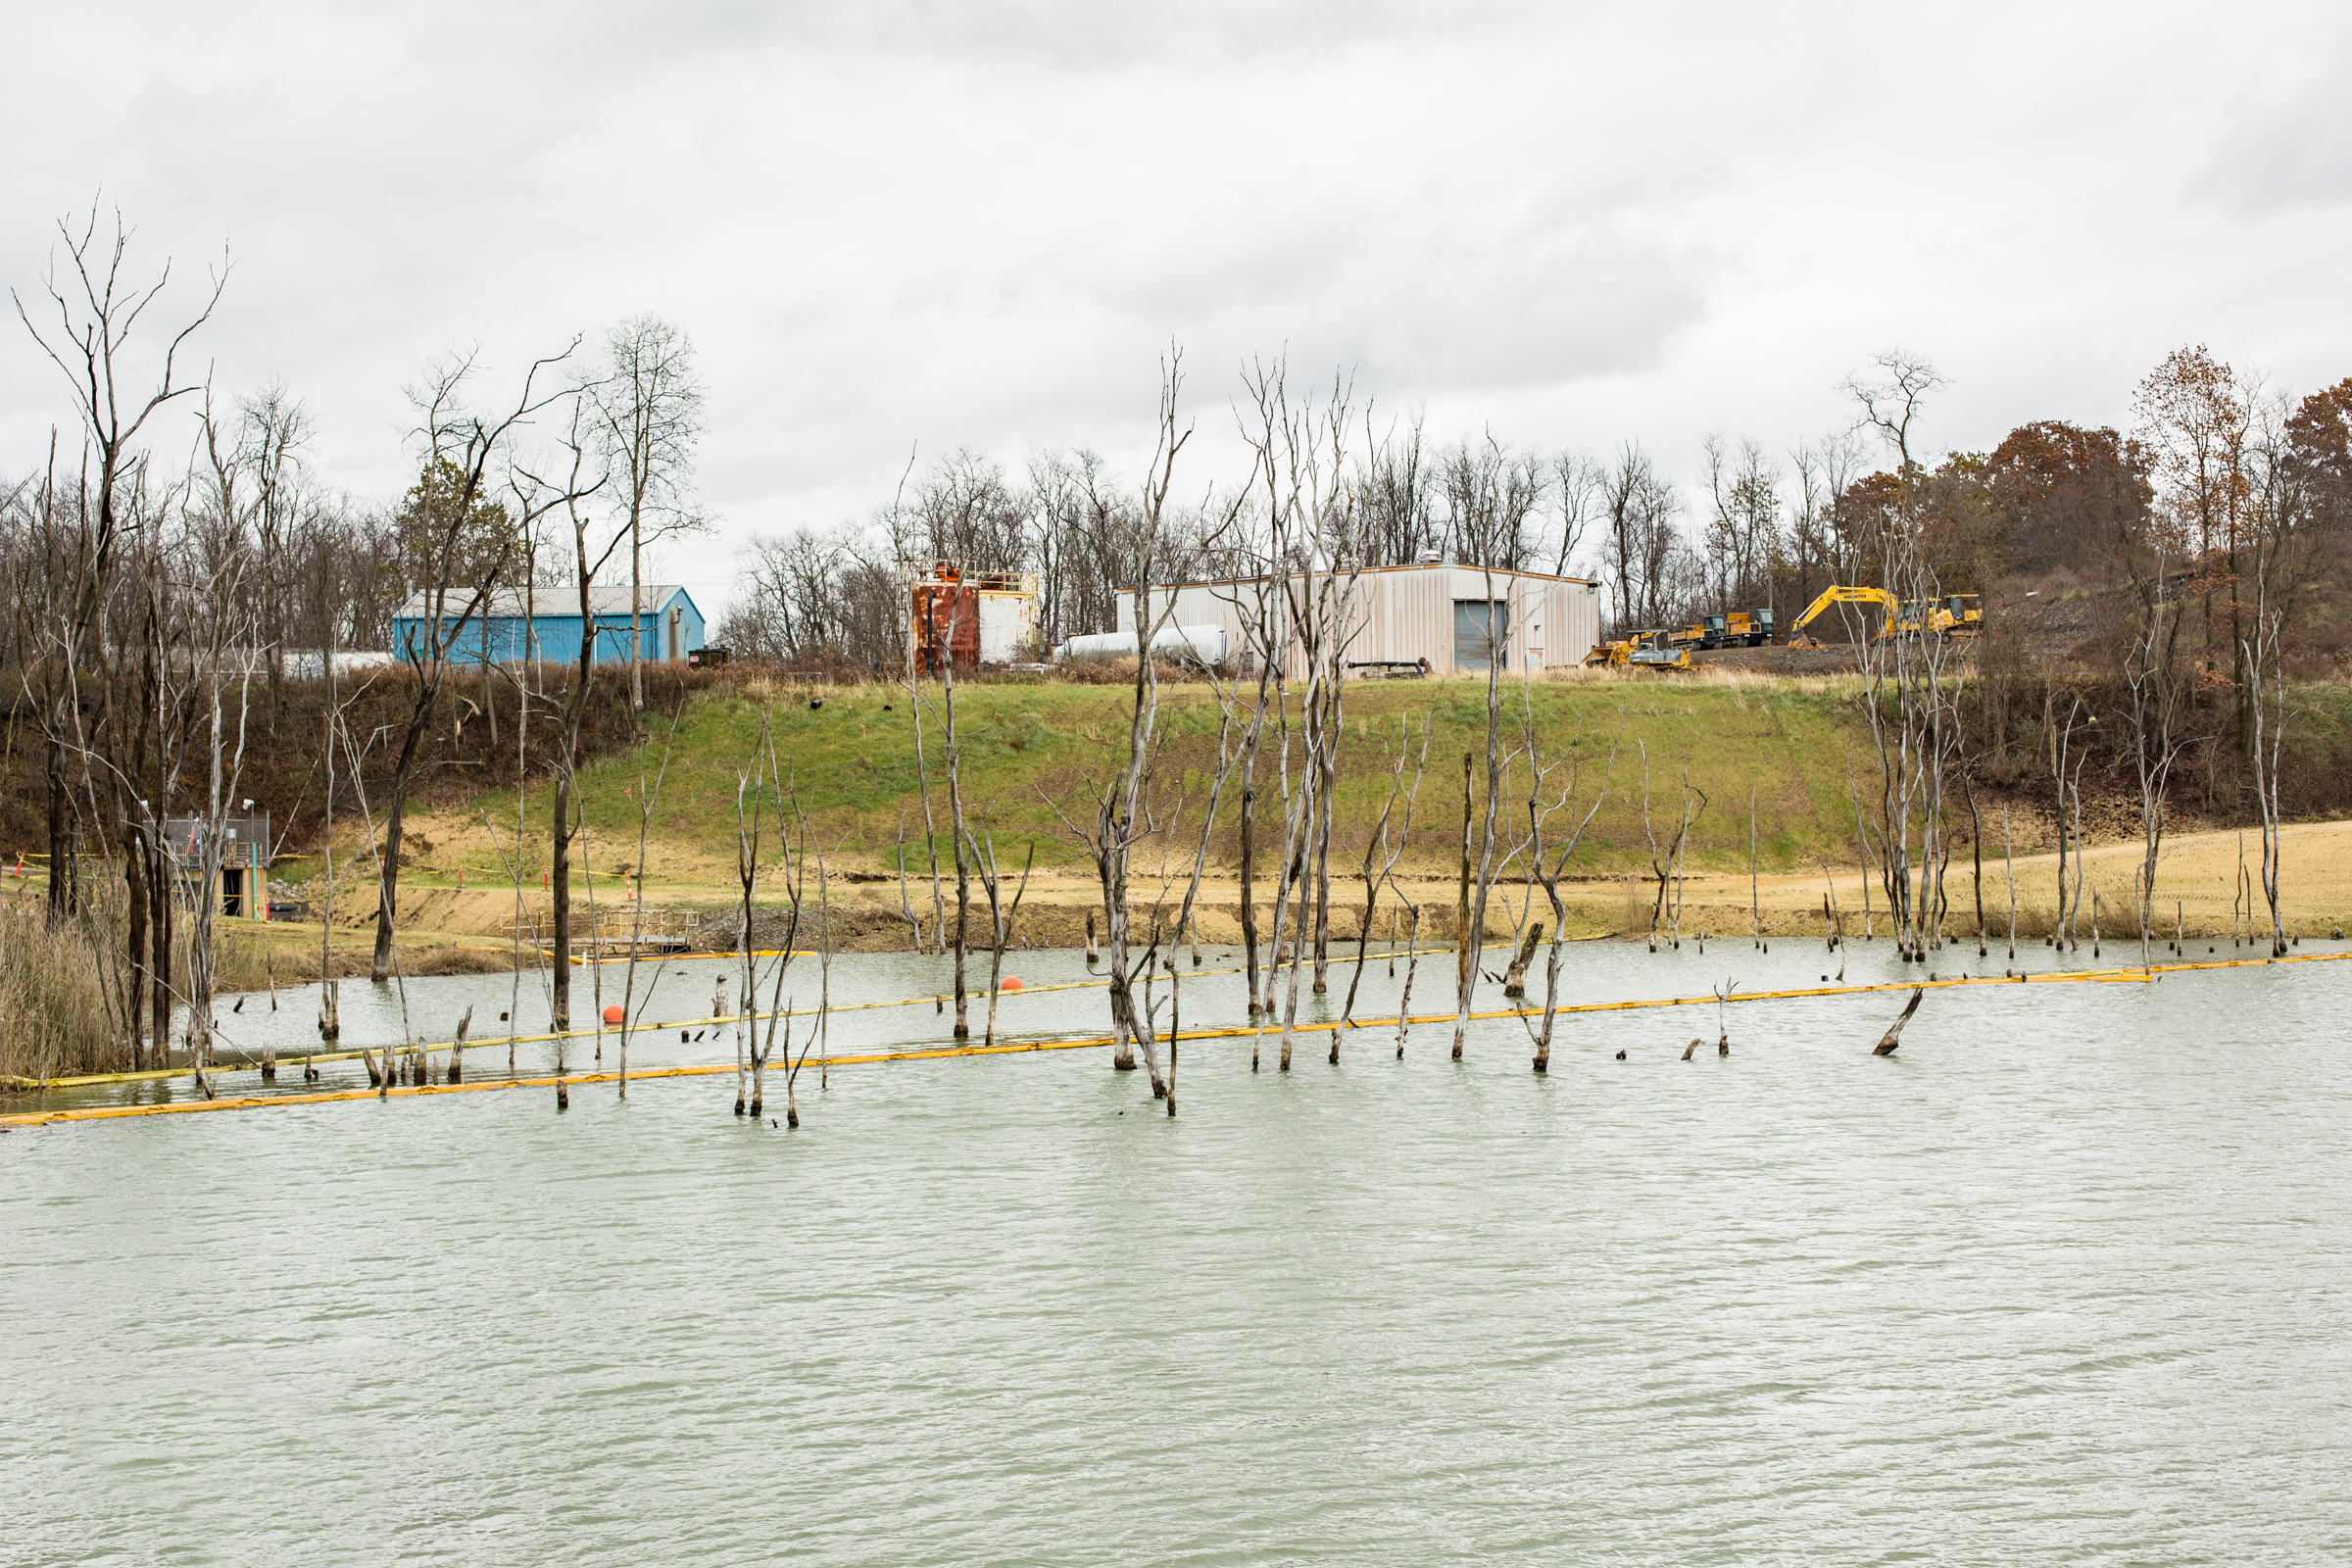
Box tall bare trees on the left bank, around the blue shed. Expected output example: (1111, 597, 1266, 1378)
(0, 212, 706, 1093)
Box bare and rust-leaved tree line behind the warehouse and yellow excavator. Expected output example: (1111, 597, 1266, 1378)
(717, 348, 2352, 672)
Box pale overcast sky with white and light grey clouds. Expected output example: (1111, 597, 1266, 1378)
(0, 0, 2352, 609)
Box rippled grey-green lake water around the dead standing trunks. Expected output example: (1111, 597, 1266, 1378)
(0, 941, 2352, 1563)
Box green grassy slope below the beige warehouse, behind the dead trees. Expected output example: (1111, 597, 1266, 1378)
(444, 677, 1875, 882)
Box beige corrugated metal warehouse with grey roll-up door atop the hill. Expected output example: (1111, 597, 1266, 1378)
(1117, 566, 1601, 679)
